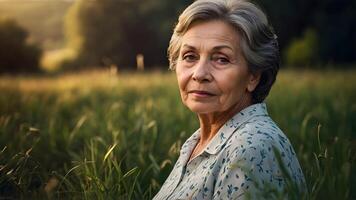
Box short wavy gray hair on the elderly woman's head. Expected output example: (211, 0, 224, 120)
(168, 0, 280, 103)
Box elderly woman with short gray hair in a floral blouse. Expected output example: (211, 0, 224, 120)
(154, 0, 305, 199)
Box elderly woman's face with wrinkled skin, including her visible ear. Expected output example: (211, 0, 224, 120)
(176, 20, 258, 114)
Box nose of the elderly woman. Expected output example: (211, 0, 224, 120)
(192, 59, 213, 82)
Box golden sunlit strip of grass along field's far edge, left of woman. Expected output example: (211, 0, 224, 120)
(0, 70, 176, 93)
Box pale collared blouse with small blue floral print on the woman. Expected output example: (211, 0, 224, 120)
(153, 103, 305, 200)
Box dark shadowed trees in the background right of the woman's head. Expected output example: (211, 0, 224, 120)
(256, 0, 356, 64)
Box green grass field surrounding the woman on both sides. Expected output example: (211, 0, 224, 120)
(0, 70, 356, 199)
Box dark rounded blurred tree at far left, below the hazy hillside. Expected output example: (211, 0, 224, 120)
(0, 19, 42, 73)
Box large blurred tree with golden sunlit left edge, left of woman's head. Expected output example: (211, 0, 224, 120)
(66, 0, 191, 68)
